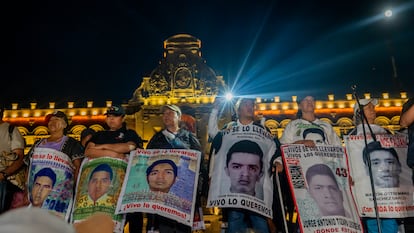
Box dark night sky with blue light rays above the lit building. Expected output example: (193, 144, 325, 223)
(6, 0, 414, 107)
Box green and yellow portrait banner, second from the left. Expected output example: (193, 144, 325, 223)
(72, 157, 128, 232)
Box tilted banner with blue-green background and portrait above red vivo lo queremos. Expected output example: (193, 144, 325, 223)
(116, 149, 200, 226)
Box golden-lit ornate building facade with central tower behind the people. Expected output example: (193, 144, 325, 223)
(4, 34, 407, 157)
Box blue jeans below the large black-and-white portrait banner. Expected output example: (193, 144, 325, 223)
(227, 209, 269, 233)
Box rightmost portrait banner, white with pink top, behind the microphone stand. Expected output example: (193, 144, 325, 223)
(344, 135, 414, 218)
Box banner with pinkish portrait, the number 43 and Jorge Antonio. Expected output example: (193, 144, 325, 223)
(282, 144, 362, 233)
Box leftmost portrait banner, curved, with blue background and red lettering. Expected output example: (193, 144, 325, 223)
(28, 148, 74, 221)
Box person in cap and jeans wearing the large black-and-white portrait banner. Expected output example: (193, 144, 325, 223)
(209, 98, 278, 233)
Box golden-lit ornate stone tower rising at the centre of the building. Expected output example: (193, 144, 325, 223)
(126, 34, 225, 155)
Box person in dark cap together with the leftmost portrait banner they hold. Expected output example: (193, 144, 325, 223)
(25, 111, 84, 219)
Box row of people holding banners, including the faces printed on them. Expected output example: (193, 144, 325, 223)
(0, 95, 414, 233)
